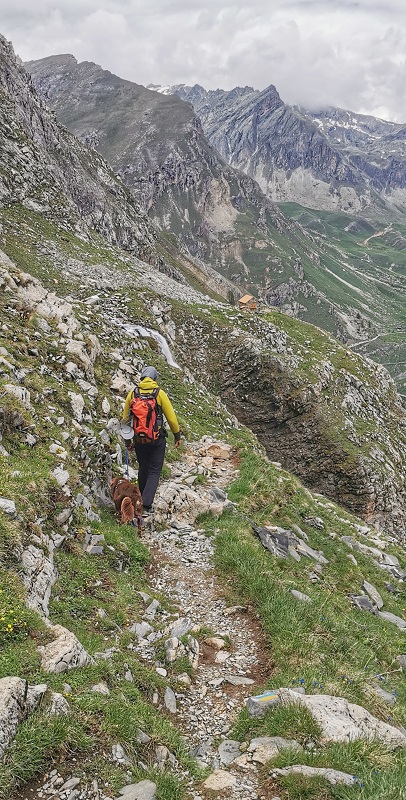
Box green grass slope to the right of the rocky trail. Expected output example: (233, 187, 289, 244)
(206, 442, 406, 800)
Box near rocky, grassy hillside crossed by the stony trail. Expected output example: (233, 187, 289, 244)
(0, 230, 406, 800)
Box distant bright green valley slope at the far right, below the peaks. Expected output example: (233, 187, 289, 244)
(281, 203, 406, 391)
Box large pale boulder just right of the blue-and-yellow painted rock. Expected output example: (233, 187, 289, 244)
(278, 689, 406, 749)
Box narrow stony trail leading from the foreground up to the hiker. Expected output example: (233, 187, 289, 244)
(16, 437, 266, 800)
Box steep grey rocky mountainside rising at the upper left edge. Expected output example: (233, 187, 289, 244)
(0, 36, 156, 258)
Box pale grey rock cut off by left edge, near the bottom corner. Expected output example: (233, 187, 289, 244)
(0, 677, 47, 758)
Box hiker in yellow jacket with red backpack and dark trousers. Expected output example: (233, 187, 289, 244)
(122, 367, 181, 515)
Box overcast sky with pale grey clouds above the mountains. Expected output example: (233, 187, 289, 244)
(0, 0, 406, 123)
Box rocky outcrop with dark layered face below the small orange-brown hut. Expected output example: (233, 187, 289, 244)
(173, 306, 406, 539)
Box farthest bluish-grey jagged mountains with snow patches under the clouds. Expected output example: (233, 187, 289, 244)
(150, 84, 406, 216)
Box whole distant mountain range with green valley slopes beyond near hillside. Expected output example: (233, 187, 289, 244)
(25, 55, 406, 387)
